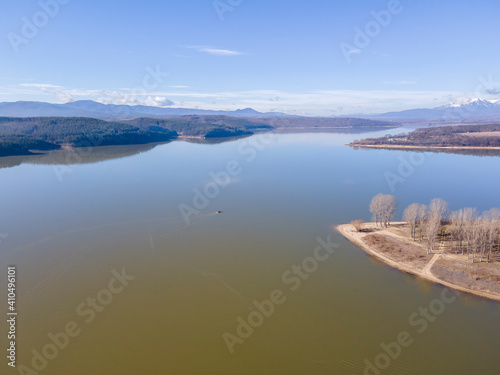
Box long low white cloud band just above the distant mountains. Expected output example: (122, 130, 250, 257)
(8, 83, 468, 116)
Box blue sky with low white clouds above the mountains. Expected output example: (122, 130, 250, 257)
(0, 0, 500, 116)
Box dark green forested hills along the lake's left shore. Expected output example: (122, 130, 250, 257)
(0, 116, 273, 156)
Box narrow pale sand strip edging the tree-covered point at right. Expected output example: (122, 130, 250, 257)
(335, 222, 500, 302)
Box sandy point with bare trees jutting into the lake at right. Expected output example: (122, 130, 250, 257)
(336, 194, 500, 301)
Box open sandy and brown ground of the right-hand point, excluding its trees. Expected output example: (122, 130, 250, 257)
(336, 222, 500, 301)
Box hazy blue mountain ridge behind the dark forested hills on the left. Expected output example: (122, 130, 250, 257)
(0, 100, 288, 120)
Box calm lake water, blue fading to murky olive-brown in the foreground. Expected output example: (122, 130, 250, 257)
(0, 131, 500, 375)
